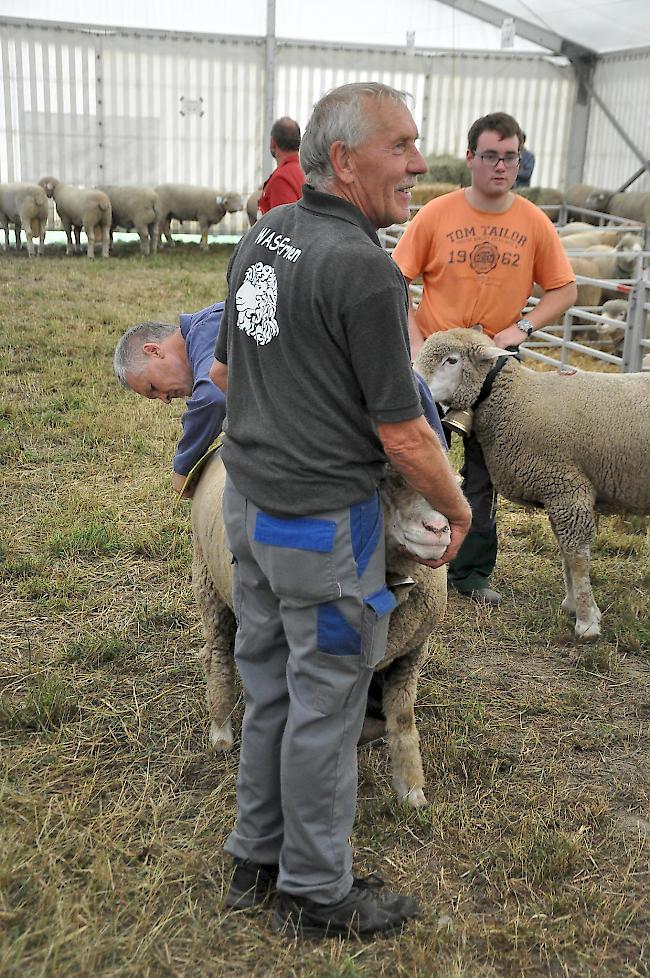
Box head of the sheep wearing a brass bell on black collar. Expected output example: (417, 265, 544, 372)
(414, 329, 512, 409)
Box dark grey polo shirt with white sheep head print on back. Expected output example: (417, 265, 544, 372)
(215, 186, 422, 516)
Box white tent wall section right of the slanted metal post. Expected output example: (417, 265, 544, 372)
(584, 48, 650, 191)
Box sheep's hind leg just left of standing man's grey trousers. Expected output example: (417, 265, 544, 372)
(192, 535, 237, 751)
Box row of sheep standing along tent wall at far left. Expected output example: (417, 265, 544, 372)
(0, 177, 244, 258)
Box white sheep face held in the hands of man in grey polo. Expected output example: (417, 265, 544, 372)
(381, 470, 451, 560)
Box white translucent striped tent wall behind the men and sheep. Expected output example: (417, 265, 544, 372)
(0, 18, 650, 233)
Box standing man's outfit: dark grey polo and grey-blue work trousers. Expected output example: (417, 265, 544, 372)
(216, 187, 422, 903)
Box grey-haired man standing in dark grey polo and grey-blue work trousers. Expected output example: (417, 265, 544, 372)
(210, 82, 471, 937)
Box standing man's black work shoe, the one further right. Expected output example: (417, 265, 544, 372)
(271, 876, 420, 938)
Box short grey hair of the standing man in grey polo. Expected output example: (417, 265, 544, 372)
(300, 82, 410, 190)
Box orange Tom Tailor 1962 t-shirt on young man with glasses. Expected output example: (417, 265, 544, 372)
(393, 189, 575, 336)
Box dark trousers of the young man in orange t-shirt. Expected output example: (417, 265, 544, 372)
(448, 434, 497, 594)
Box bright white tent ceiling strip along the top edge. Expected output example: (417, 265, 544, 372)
(0, 0, 650, 53)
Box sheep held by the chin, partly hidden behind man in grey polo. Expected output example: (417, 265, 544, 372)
(192, 455, 450, 808)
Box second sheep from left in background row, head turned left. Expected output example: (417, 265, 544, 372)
(38, 177, 112, 258)
